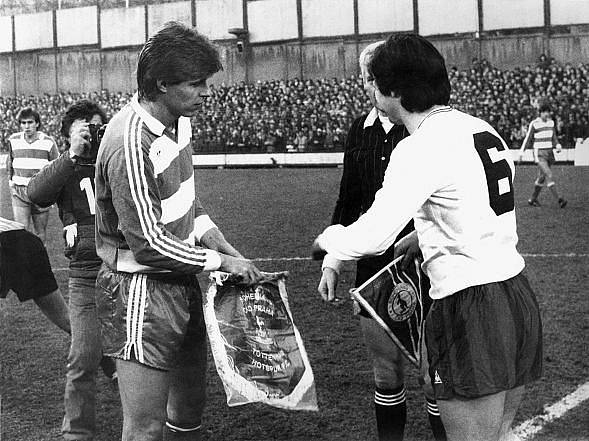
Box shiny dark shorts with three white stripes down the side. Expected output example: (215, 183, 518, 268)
(96, 265, 206, 370)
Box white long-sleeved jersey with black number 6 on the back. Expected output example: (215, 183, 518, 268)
(318, 107, 524, 299)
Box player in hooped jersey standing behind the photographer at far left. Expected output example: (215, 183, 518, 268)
(6, 107, 58, 243)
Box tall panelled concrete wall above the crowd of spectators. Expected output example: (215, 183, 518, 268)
(0, 0, 589, 94)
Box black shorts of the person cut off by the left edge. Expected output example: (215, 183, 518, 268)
(0, 230, 58, 302)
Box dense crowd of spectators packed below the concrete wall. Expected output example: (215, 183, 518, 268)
(0, 56, 589, 153)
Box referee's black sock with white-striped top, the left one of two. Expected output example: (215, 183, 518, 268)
(374, 386, 407, 441)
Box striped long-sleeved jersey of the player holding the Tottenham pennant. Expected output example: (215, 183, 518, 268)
(96, 95, 220, 274)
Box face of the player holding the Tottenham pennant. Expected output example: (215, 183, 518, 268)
(163, 79, 210, 118)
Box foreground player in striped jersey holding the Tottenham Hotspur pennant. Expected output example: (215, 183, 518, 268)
(96, 22, 262, 441)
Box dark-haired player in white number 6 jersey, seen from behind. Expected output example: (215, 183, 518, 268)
(313, 34, 542, 441)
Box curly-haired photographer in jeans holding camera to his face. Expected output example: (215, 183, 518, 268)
(28, 100, 116, 440)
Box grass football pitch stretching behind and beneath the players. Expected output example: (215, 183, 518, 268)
(0, 166, 589, 441)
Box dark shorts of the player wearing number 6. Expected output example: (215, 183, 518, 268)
(426, 274, 542, 400)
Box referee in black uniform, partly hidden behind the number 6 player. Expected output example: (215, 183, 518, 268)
(318, 41, 446, 441)
